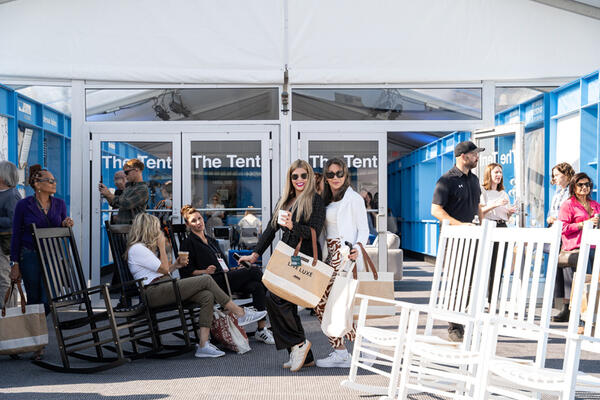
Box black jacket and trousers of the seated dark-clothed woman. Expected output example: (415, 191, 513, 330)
(179, 233, 267, 311)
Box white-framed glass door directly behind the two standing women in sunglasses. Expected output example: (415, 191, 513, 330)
(297, 130, 387, 271)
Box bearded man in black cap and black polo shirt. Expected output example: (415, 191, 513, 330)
(431, 141, 485, 342)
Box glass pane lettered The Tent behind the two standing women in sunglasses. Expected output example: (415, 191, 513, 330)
(308, 140, 379, 241)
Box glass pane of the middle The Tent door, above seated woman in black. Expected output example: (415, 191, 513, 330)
(184, 140, 263, 258)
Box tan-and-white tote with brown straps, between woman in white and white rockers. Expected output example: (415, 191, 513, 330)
(354, 243, 396, 320)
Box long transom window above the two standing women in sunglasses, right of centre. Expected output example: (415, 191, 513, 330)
(292, 88, 481, 121)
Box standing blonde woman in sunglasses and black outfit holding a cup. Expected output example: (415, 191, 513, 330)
(239, 160, 325, 372)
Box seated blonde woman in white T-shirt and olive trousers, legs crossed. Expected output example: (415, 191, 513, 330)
(127, 213, 267, 358)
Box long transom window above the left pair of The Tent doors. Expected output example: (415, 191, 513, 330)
(85, 88, 279, 121)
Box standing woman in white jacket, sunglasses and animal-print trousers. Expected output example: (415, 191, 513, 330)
(315, 158, 369, 368)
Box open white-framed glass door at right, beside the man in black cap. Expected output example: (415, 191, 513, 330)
(473, 123, 524, 227)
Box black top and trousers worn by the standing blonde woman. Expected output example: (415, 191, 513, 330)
(254, 194, 325, 352)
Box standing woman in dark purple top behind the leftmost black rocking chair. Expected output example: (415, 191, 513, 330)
(10, 164, 73, 359)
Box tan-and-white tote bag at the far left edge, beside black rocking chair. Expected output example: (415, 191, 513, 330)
(0, 281, 48, 354)
